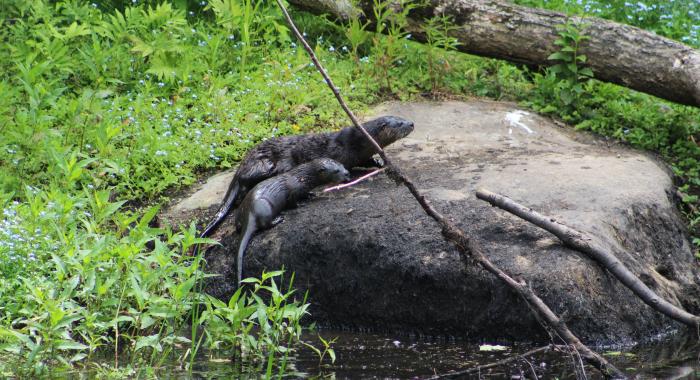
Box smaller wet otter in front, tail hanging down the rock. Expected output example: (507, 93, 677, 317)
(235, 158, 350, 287)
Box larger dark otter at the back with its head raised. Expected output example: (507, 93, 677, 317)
(195, 116, 413, 243)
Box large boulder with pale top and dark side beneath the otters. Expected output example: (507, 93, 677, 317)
(165, 101, 699, 343)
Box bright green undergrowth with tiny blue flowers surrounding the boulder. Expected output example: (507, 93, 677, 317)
(0, 0, 700, 376)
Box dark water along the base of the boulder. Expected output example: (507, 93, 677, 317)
(183, 330, 700, 379)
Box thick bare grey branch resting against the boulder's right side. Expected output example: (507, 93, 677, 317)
(476, 189, 700, 329)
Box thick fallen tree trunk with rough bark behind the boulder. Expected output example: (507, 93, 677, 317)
(289, 0, 700, 107)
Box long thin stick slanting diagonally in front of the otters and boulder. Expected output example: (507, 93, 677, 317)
(277, 0, 625, 378)
